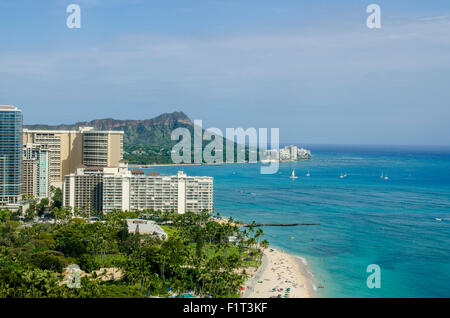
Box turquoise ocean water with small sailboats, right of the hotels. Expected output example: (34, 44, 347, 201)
(143, 146, 450, 297)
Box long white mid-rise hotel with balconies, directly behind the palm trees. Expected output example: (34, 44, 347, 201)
(63, 162, 213, 214)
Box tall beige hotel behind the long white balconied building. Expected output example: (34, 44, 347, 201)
(23, 127, 124, 187)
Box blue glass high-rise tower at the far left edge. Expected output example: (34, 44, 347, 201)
(0, 105, 22, 206)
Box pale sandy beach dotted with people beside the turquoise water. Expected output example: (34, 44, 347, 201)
(242, 247, 313, 298)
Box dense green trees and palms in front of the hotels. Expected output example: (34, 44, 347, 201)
(0, 188, 268, 298)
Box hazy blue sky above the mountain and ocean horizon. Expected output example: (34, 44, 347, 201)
(0, 0, 450, 145)
